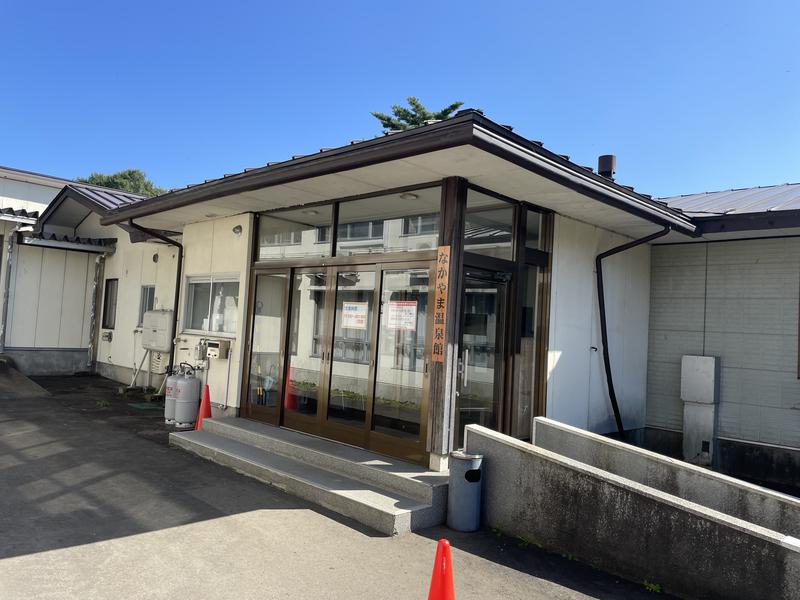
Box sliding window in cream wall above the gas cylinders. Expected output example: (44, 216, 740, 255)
(184, 277, 239, 334)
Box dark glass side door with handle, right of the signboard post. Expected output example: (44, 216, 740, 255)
(455, 269, 508, 447)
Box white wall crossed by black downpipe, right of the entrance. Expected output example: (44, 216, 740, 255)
(547, 215, 650, 433)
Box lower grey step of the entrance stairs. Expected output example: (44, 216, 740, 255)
(170, 428, 442, 535)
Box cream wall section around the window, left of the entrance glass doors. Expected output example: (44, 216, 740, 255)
(175, 214, 253, 407)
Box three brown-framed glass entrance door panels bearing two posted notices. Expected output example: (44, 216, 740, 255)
(274, 262, 433, 462)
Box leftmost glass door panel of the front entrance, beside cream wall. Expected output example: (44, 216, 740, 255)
(243, 272, 289, 425)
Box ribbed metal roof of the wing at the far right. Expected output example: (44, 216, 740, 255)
(659, 183, 800, 217)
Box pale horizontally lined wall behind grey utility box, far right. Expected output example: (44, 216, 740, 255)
(647, 238, 800, 448)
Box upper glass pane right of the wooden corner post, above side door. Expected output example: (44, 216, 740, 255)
(464, 190, 514, 260)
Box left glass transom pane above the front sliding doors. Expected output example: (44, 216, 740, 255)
(256, 205, 332, 260)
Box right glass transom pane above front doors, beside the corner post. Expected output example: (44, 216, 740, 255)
(336, 187, 442, 256)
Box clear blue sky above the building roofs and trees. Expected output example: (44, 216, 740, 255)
(0, 0, 800, 196)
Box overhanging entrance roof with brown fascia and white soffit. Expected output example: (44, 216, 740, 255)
(101, 110, 695, 235)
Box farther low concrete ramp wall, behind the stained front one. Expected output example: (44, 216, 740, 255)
(532, 417, 800, 538)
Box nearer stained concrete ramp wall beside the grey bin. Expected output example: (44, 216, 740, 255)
(465, 425, 800, 600)
